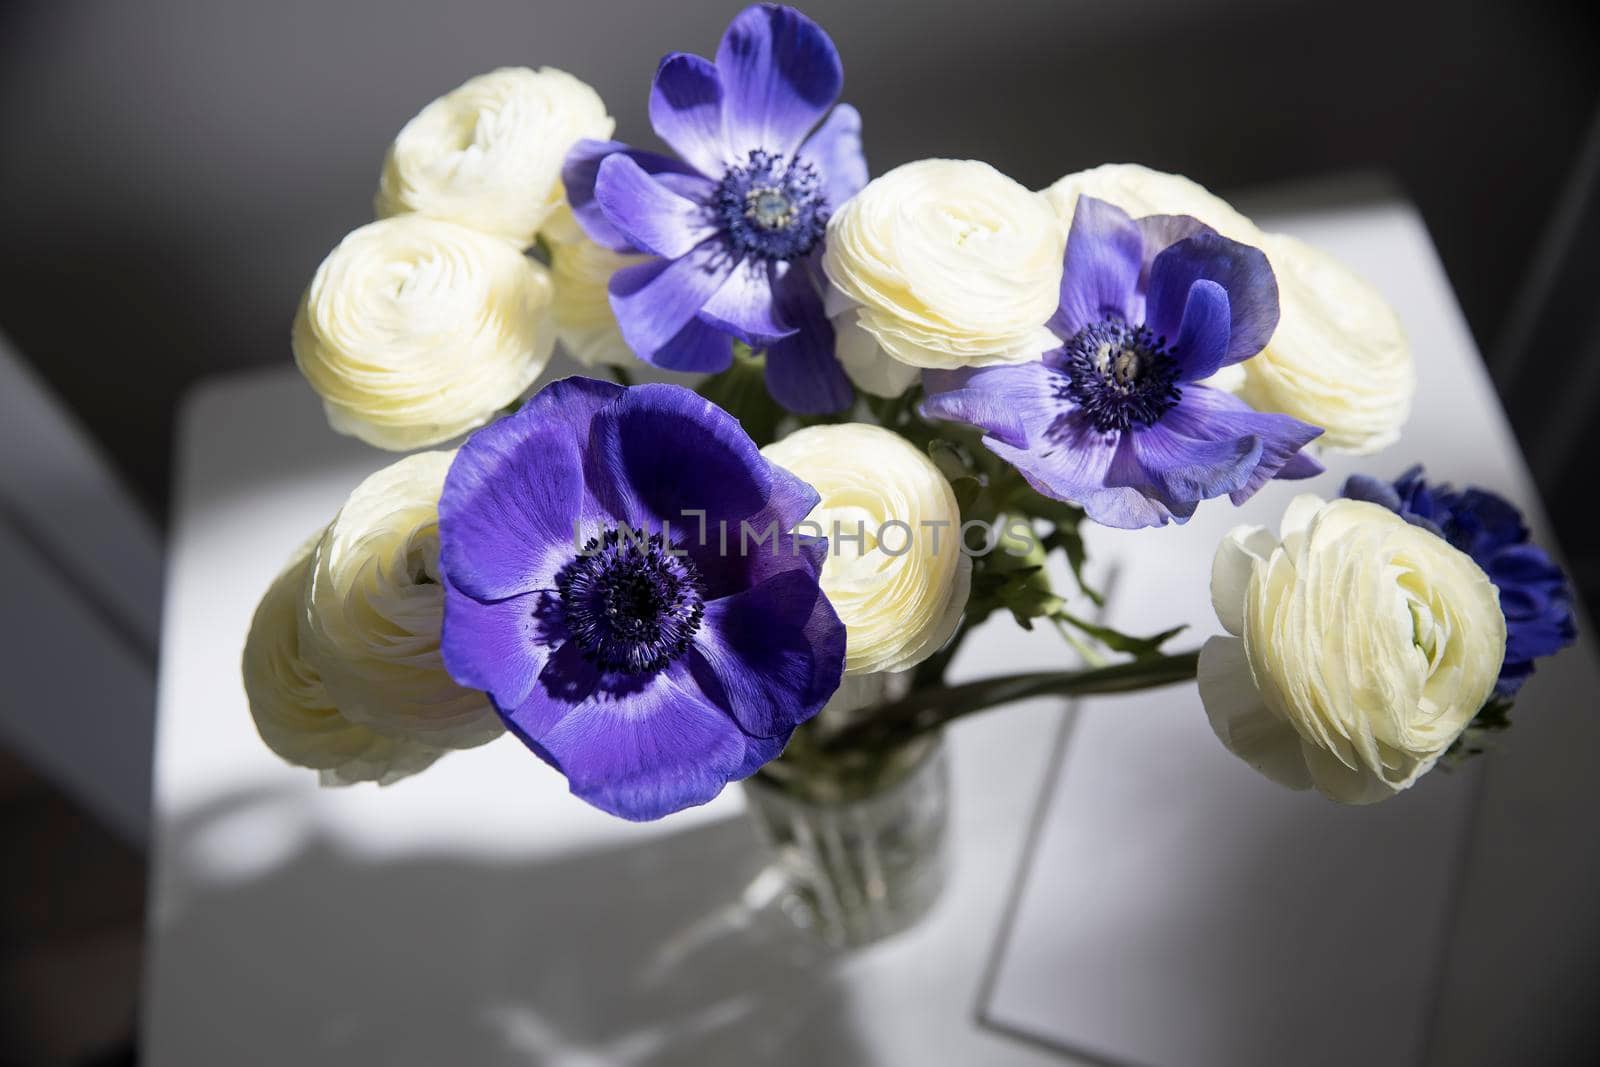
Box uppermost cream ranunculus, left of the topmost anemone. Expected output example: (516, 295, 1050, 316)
(374, 67, 616, 248)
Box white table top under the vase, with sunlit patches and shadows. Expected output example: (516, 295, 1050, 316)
(142, 195, 1600, 1067)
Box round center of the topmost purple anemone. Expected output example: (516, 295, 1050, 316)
(715, 149, 827, 259)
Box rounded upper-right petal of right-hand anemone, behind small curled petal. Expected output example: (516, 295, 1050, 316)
(1145, 231, 1278, 367)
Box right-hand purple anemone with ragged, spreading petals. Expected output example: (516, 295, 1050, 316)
(922, 197, 1322, 530)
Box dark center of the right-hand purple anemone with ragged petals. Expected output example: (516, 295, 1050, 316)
(1056, 318, 1182, 434)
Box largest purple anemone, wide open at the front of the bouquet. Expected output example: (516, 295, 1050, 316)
(438, 378, 845, 819)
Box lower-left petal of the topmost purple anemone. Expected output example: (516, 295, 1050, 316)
(610, 238, 739, 362)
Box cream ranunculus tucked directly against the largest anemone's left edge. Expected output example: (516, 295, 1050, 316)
(299, 451, 502, 749)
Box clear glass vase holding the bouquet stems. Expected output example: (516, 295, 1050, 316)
(746, 675, 950, 949)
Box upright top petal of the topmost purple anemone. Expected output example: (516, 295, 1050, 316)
(717, 5, 845, 158)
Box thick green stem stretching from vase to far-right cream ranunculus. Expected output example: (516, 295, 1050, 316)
(821, 651, 1200, 753)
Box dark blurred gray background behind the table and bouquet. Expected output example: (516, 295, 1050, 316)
(0, 0, 1600, 1065)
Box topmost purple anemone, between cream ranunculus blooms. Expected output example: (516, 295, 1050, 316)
(563, 5, 867, 414)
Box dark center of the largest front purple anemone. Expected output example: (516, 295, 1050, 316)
(555, 530, 706, 673)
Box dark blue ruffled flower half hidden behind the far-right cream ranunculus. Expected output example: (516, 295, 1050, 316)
(1344, 467, 1578, 701)
